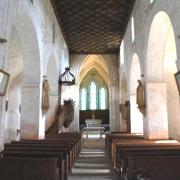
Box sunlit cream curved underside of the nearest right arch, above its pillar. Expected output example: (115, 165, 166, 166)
(146, 11, 176, 81)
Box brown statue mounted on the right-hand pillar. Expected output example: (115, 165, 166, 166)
(136, 80, 145, 115)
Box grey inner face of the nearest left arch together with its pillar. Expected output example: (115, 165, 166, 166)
(7, 14, 41, 139)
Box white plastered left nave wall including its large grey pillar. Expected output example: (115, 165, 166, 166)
(0, 0, 69, 149)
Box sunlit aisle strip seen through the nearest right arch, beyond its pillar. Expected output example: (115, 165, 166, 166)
(164, 20, 180, 138)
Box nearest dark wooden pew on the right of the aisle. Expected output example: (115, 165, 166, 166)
(121, 155, 180, 180)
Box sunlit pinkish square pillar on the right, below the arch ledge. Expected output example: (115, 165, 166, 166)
(144, 82, 169, 139)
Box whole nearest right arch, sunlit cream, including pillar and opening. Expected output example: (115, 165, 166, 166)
(145, 11, 180, 138)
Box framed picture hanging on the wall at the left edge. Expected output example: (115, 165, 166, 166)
(0, 69, 10, 96)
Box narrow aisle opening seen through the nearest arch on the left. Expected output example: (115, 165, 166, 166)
(4, 27, 23, 142)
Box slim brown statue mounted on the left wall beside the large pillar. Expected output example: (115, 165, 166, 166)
(42, 76, 50, 111)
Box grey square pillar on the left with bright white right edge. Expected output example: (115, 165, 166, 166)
(20, 84, 45, 139)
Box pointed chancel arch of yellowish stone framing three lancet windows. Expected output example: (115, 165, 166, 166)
(78, 55, 110, 129)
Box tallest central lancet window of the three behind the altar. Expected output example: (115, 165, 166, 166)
(90, 82, 97, 109)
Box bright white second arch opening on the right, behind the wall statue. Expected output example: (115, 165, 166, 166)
(130, 54, 143, 133)
